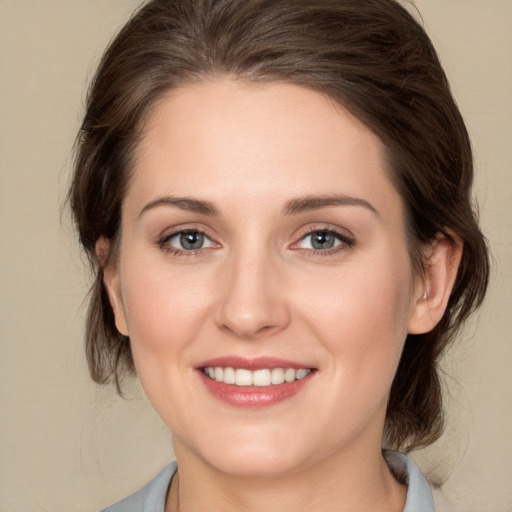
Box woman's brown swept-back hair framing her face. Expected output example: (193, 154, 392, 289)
(69, 0, 489, 451)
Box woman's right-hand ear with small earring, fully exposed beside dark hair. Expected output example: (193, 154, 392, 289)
(408, 233, 463, 334)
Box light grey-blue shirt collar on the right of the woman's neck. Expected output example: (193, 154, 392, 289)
(384, 451, 435, 512)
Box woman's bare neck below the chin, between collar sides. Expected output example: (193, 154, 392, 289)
(166, 447, 406, 512)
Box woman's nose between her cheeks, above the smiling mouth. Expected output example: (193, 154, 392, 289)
(216, 248, 290, 340)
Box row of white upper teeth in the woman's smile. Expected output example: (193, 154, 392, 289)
(203, 366, 311, 387)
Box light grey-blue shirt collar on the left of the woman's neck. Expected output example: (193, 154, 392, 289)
(101, 462, 177, 512)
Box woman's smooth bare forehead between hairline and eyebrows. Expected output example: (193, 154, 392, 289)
(127, 79, 400, 218)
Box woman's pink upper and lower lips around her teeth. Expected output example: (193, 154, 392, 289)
(196, 357, 317, 409)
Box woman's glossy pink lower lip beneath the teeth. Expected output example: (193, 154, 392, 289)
(198, 370, 316, 408)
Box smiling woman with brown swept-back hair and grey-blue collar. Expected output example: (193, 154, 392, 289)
(70, 0, 488, 512)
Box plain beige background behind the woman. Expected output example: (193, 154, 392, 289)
(0, 0, 512, 512)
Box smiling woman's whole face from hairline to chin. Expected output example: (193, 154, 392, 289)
(106, 79, 422, 476)
